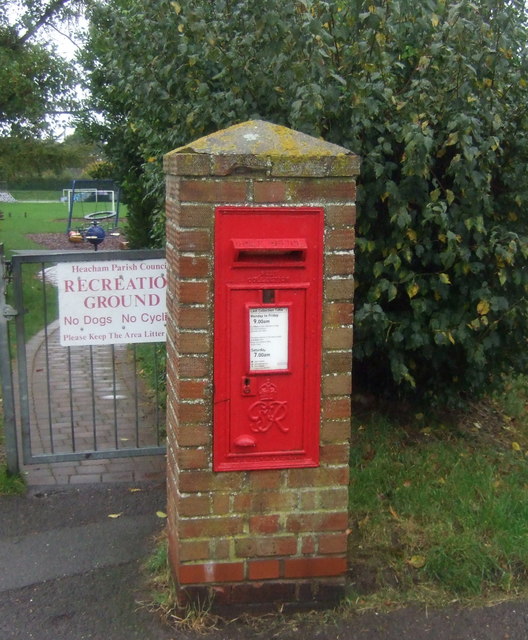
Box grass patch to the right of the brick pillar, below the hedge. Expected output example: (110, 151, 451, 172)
(349, 388, 528, 608)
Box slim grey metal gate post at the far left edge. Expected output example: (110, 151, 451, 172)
(0, 243, 20, 473)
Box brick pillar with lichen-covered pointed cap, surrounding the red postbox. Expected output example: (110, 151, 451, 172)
(165, 121, 359, 608)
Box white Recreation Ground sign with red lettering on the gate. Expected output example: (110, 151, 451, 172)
(57, 259, 167, 347)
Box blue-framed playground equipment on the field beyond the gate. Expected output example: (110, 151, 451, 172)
(63, 180, 120, 251)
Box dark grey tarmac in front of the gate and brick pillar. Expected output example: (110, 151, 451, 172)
(0, 485, 528, 640)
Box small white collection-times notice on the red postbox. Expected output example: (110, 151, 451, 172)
(249, 307, 288, 371)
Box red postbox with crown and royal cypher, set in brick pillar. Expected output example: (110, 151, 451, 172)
(213, 207, 324, 471)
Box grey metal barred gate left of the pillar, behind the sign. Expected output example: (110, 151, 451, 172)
(0, 248, 165, 477)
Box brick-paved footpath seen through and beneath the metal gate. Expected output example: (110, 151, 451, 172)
(21, 322, 165, 486)
